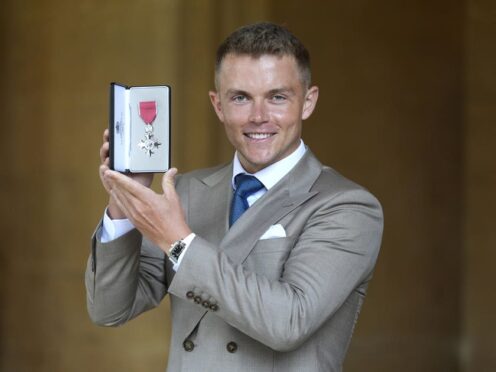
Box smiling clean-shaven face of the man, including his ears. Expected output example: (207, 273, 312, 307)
(210, 54, 318, 173)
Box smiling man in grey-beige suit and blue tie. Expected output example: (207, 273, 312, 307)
(86, 23, 382, 372)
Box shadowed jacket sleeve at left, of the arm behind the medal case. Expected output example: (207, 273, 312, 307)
(85, 226, 169, 326)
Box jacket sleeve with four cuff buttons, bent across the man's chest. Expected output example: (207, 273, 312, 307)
(169, 190, 382, 351)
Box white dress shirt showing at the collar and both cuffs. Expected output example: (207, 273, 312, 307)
(100, 140, 306, 271)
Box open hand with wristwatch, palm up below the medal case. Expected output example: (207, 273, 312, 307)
(103, 168, 191, 253)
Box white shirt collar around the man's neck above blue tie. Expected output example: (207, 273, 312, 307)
(231, 140, 307, 190)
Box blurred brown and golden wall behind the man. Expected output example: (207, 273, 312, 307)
(0, 0, 496, 372)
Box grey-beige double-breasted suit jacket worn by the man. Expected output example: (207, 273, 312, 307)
(86, 151, 383, 372)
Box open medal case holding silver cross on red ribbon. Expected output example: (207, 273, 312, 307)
(109, 83, 171, 173)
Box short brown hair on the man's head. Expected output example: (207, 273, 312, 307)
(215, 22, 311, 88)
